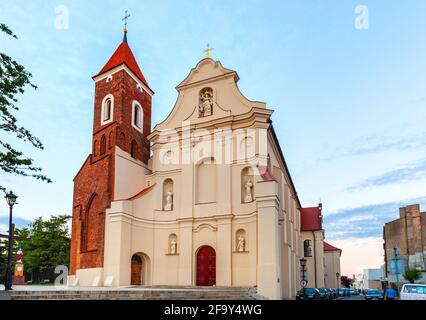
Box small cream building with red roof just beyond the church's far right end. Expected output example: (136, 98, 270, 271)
(324, 241, 342, 288)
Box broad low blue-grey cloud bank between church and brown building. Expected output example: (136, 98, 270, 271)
(324, 197, 426, 240)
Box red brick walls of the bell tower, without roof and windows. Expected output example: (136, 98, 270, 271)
(70, 70, 151, 275)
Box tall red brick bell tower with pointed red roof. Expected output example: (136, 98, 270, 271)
(70, 30, 154, 275)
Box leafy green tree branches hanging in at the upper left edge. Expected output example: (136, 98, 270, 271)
(0, 23, 51, 190)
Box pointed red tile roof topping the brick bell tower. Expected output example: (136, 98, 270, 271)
(95, 37, 149, 88)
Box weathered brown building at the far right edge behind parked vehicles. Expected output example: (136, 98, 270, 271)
(383, 204, 426, 283)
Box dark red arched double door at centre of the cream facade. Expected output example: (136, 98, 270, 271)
(196, 246, 216, 286)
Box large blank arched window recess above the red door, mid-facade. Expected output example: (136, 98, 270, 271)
(195, 158, 217, 203)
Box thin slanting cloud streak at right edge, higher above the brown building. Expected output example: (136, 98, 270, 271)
(347, 160, 426, 191)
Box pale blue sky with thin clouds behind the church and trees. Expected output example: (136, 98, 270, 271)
(0, 0, 426, 275)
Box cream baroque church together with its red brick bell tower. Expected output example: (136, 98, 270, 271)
(68, 30, 342, 299)
